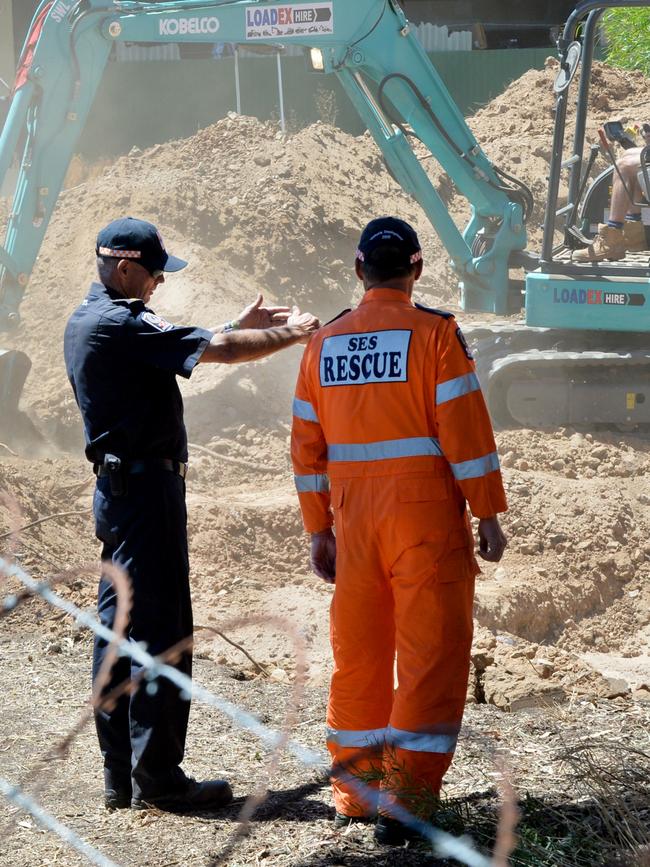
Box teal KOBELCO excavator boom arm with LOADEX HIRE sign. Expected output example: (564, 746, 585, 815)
(0, 0, 526, 329)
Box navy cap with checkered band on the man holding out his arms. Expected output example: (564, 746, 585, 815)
(95, 217, 187, 271)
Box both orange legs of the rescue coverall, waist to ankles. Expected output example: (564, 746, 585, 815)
(328, 474, 476, 815)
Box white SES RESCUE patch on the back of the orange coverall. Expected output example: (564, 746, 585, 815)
(320, 331, 412, 388)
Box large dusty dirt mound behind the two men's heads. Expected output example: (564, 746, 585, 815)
(5, 116, 451, 447)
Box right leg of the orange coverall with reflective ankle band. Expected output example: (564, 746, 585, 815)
(380, 532, 475, 818)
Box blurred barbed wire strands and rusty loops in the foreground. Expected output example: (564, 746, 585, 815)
(0, 558, 492, 867)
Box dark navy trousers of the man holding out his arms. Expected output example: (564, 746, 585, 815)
(93, 470, 192, 797)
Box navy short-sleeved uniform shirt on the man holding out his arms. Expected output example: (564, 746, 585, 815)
(64, 283, 213, 463)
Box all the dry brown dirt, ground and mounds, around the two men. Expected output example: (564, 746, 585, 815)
(0, 66, 650, 867)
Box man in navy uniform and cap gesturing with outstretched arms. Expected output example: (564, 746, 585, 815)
(65, 217, 318, 812)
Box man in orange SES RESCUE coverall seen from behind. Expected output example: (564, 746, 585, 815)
(292, 218, 507, 844)
